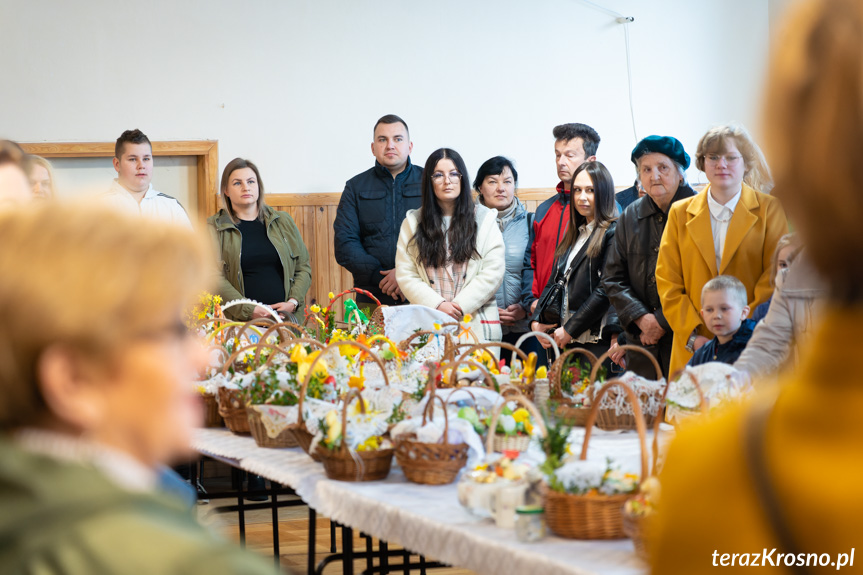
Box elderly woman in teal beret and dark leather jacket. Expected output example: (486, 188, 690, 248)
(602, 136, 695, 379)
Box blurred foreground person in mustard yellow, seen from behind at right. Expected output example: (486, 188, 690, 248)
(651, 0, 863, 575)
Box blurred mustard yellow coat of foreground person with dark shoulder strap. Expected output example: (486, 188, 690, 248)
(651, 307, 863, 575)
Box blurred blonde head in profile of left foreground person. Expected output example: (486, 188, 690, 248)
(0, 202, 209, 465)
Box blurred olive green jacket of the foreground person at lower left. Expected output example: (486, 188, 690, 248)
(0, 434, 276, 575)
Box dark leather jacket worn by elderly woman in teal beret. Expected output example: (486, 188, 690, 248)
(602, 184, 695, 341)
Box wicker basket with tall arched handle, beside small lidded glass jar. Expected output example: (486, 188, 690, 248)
(545, 380, 647, 539)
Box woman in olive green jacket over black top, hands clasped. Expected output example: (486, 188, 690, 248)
(207, 158, 312, 321)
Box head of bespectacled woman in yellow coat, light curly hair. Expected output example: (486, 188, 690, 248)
(695, 124, 773, 193)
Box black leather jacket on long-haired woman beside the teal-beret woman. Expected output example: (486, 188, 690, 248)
(549, 222, 616, 337)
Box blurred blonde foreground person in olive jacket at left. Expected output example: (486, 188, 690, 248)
(0, 202, 273, 575)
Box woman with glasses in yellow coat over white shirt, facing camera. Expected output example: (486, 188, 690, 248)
(656, 126, 788, 373)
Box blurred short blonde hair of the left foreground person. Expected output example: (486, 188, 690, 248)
(0, 202, 209, 429)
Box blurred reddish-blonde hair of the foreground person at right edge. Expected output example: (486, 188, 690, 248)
(764, 0, 863, 303)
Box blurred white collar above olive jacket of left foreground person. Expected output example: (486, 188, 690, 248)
(15, 428, 159, 492)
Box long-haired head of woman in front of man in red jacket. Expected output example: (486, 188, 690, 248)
(555, 161, 617, 257)
